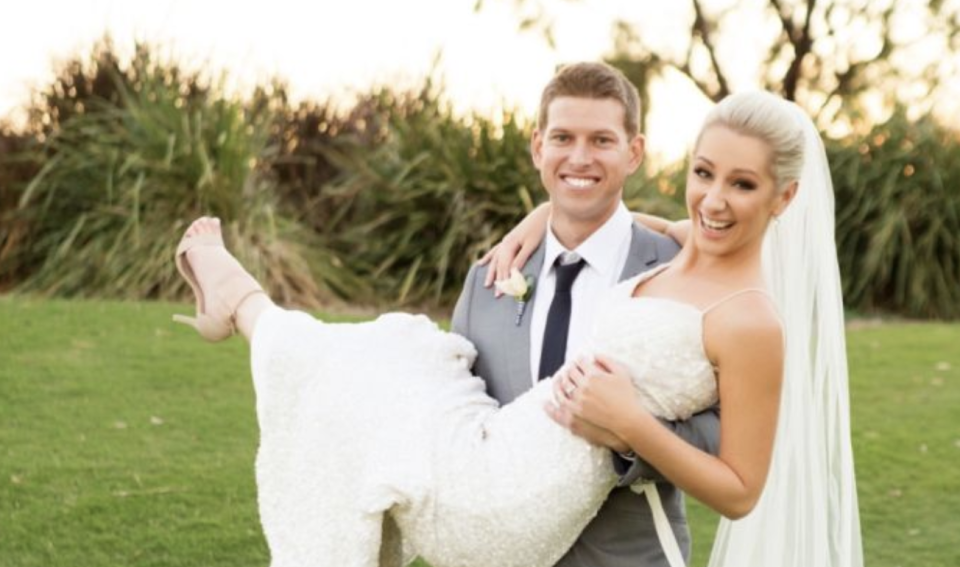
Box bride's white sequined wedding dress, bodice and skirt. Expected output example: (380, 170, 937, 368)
(252, 272, 717, 567)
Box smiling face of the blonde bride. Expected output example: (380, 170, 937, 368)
(687, 125, 797, 256)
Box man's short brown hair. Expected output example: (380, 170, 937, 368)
(537, 62, 640, 139)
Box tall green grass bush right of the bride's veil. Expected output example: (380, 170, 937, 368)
(828, 108, 960, 319)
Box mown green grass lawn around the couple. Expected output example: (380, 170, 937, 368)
(0, 297, 960, 567)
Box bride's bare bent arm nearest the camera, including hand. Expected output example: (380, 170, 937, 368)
(550, 297, 783, 518)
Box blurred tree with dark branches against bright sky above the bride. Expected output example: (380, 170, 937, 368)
(492, 0, 960, 123)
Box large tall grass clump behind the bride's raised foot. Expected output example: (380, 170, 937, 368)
(0, 40, 336, 304)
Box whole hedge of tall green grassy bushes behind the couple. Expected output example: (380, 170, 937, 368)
(0, 38, 960, 319)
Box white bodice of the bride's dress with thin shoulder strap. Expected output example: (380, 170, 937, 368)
(590, 268, 719, 421)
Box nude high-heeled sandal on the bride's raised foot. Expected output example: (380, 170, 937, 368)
(173, 233, 265, 342)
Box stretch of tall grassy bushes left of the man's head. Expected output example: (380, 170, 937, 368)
(0, 39, 676, 308)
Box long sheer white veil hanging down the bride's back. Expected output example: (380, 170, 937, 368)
(710, 103, 863, 567)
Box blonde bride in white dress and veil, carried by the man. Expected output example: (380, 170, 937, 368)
(176, 93, 862, 567)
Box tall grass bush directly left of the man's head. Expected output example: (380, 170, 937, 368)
(316, 81, 539, 303)
